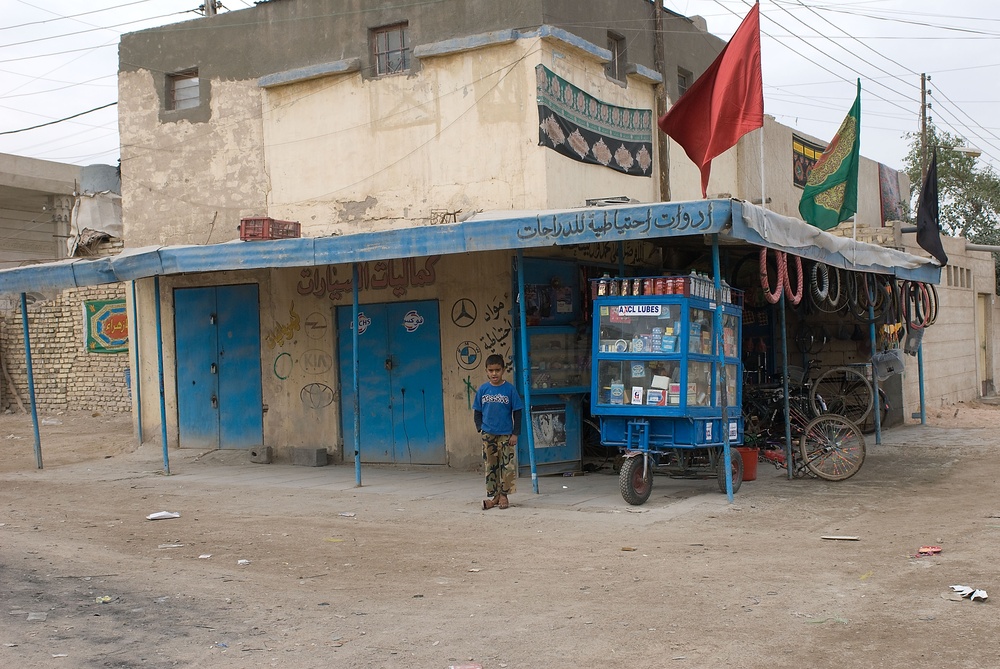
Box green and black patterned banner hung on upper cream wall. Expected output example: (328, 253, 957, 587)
(535, 65, 653, 177)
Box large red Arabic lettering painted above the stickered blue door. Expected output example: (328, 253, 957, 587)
(296, 255, 441, 301)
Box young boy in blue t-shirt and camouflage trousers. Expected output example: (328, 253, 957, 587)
(472, 353, 524, 510)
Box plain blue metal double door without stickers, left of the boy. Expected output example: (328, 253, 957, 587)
(174, 284, 264, 448)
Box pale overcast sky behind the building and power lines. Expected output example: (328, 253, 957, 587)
(0, 0, 1000, 174)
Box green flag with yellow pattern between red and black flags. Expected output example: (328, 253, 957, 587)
(799, 79, 861, 230)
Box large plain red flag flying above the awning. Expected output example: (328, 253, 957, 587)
(659, 4, 764, 197)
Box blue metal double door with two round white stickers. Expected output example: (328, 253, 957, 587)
(337, 301, 447, 465)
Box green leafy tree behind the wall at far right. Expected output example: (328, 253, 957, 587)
(903, 124, 1000, 294)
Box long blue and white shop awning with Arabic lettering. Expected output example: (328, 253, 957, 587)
(0, 200, 941, 294)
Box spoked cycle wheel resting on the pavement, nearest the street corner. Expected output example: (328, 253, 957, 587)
(799, 415, 865, 481)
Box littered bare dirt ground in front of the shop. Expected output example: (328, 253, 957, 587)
(0, 403, 1000, 669)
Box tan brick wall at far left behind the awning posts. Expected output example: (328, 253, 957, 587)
(0, 240, 132, 412)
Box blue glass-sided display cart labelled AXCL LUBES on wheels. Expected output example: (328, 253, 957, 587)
(590, 277, 743, 504)
